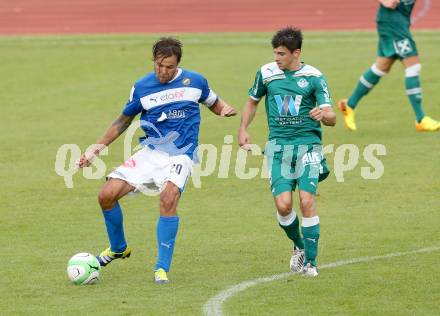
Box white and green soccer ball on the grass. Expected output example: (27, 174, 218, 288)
(67, 252, 101, 285)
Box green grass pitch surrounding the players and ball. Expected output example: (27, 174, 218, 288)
(0, 32, 440, 315)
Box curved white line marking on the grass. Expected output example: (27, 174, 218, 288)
(203, 246, 440, 316)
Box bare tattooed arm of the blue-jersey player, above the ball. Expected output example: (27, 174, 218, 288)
(77, 114, 134, 168)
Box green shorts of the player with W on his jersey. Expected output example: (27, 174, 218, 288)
(266, 144, 329, 196)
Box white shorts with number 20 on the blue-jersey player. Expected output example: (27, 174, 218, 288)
(108, 147, 193, 194)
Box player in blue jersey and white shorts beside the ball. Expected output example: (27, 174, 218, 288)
(77, 37, 236, 284)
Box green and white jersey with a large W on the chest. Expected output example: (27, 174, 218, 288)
(249, 62, 332, 145)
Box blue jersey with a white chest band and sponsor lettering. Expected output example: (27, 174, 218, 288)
(122, 68, 217, 159)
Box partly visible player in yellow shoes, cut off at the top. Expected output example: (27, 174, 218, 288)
(338, 0, 440, 132)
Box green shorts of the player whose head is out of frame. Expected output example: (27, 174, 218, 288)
(377, 22, 418, 59)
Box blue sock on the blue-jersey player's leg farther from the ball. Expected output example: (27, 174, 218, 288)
(154, 216, 179, 272)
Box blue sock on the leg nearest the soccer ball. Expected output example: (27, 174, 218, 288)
(102, 202, 127, 252)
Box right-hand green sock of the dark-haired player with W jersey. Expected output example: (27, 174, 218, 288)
(301, 216, 320, 267)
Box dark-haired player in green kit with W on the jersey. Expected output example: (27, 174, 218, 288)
(238, 27, 336, 276)
